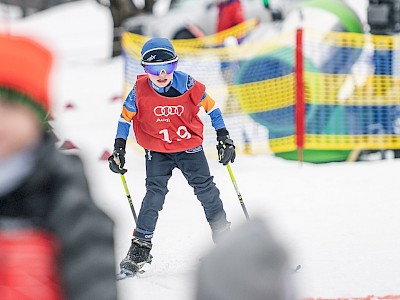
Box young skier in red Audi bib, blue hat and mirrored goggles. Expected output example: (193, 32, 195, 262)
(108, 38, 236, 273)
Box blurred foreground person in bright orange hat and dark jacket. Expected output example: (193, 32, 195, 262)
(0, 35, 117, 300)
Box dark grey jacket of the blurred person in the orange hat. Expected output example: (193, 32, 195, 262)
(0, 137, 117, 300)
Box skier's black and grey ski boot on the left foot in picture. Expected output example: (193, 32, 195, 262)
(117, 238, 153, 280)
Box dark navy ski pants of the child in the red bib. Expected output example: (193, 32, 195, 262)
(134, 147, 227, 240)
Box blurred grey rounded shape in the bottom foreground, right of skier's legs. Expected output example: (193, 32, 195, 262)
(195, 218, 299, 300)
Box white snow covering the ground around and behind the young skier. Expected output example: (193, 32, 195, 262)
(0, 1, 400, 300)
